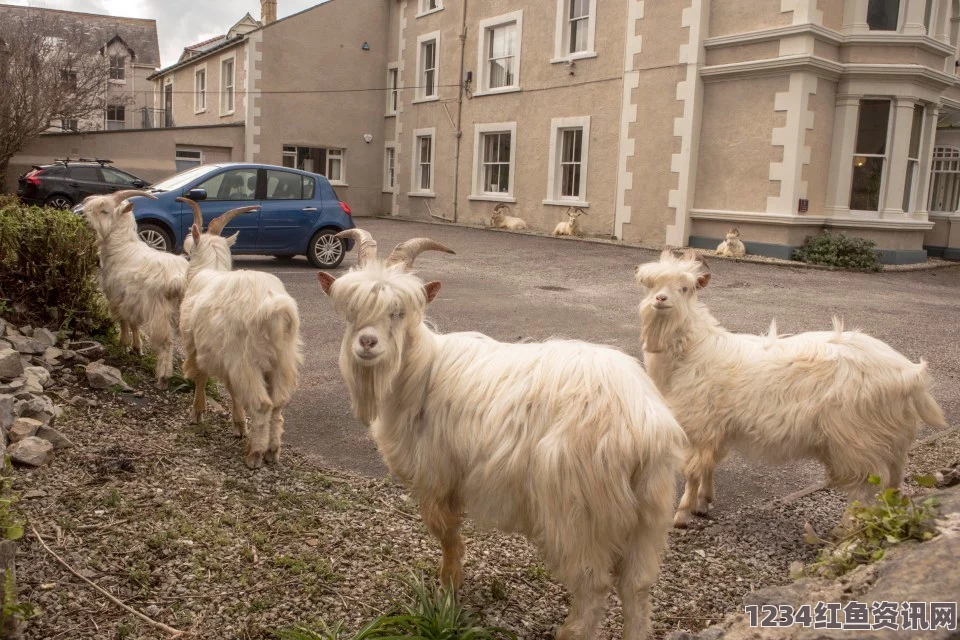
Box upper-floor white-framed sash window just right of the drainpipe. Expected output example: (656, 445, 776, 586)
(477, 11, 523, 95)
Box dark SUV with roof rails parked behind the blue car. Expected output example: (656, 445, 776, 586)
(17, 158, 148, 209)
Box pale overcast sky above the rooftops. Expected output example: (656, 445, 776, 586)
(0, 0, 322, 67)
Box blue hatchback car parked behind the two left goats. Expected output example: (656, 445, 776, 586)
(108, 163, 355, 269)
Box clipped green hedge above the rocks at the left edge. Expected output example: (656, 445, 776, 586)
(0, 197, 112, 333)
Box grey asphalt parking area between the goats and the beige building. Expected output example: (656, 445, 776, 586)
(235, 218, 960, 509)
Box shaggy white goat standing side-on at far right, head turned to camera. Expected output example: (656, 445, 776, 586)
(636, 251, 946, 527)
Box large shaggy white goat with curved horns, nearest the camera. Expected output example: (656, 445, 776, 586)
(317, 229, 684, 640)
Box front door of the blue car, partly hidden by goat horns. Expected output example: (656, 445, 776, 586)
(180, 167, 260, 252)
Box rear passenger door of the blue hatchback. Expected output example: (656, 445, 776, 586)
(257, 169, 320, 254)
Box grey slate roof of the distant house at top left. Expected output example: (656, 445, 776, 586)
(0, 4, 160, 68)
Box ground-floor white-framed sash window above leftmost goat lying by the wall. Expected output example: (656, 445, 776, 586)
(472, 122, 517, 201)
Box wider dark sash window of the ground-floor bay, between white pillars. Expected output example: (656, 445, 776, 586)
(850, 100, 890, 211)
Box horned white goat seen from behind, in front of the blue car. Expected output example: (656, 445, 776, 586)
(177, 198, 303, 469)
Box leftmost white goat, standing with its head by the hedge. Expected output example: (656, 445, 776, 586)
(83, 191, 187, 389)
